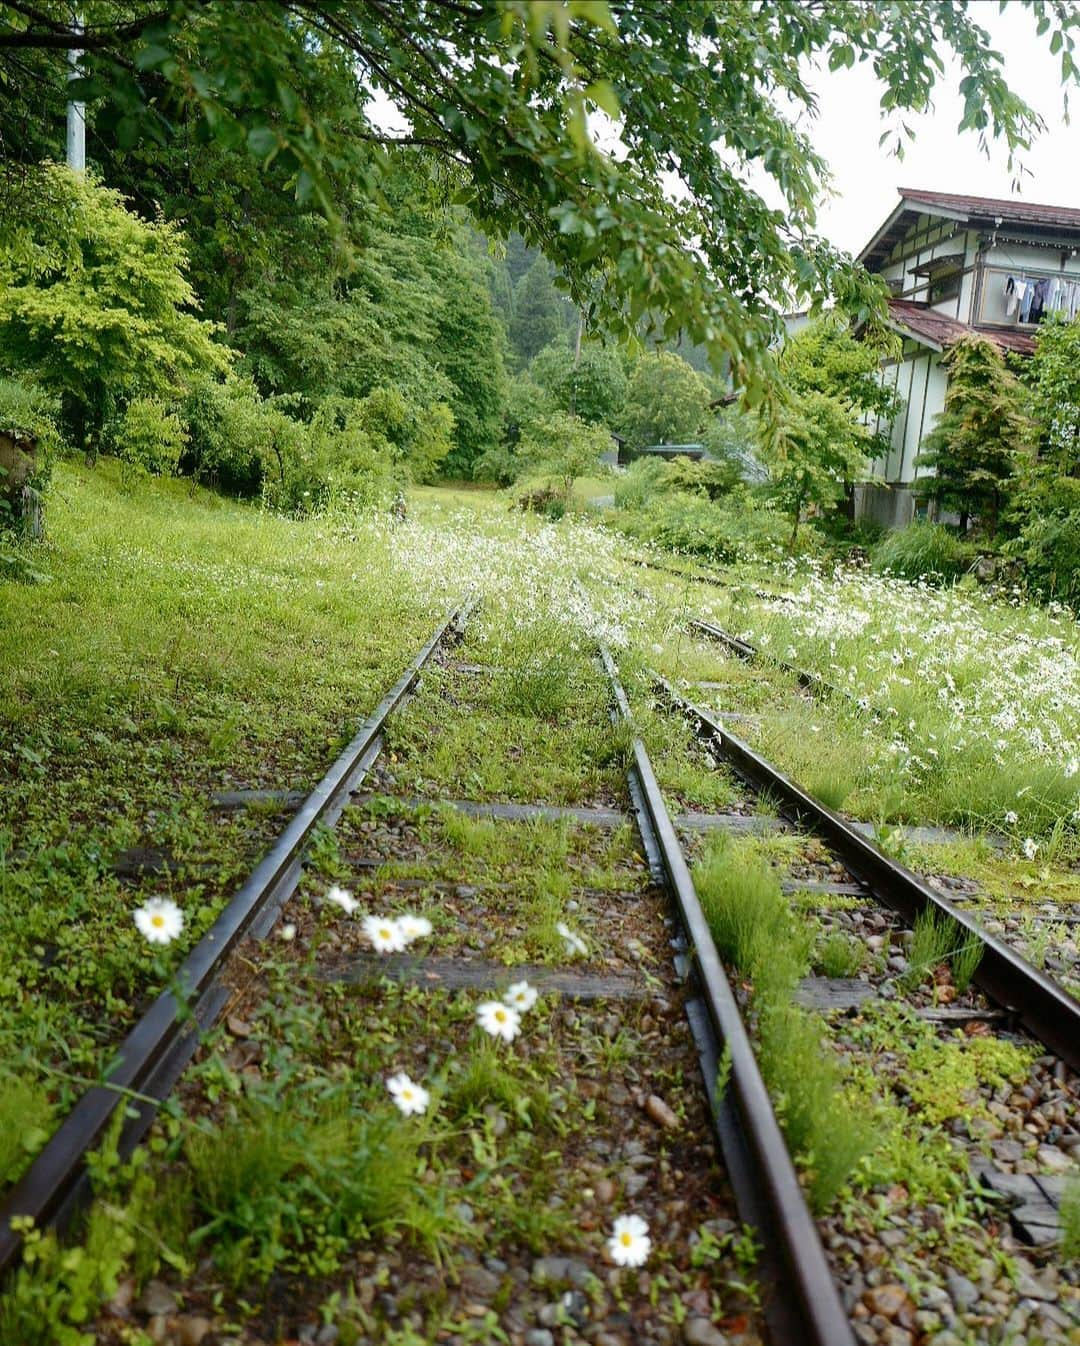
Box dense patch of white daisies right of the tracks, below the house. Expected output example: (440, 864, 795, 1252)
(702, 557, 1080, 821)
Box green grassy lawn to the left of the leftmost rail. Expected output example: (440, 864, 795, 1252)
(0, 462, 443, 1133)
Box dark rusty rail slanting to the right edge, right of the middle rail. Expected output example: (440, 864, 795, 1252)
(653, 674, 1080, 1070)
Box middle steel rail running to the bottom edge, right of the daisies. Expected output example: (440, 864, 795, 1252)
(601, 647, 855, 1346)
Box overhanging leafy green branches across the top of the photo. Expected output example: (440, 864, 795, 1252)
(0, 0, 1080, 401)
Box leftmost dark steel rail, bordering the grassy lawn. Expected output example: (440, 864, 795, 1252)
(0, 602, 473, 1275)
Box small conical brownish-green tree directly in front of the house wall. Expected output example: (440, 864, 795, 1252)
(916, 335, 1033, 536)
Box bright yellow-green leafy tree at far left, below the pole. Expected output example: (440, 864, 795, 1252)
(0, 166, 228, 452)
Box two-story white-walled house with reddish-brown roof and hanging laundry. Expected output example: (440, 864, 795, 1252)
(855, 187, 1080, 526)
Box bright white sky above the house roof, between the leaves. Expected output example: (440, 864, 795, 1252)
(804, 0, 1080, 252)
